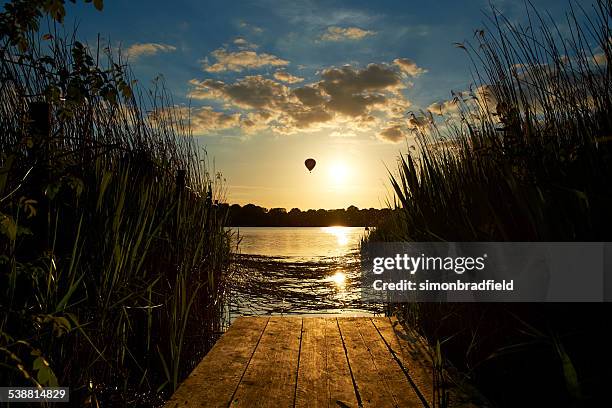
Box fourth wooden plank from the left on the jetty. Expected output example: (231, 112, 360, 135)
(338, 318, 423, 408)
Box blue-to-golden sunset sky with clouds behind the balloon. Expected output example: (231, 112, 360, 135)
(58, 0, 580, 209)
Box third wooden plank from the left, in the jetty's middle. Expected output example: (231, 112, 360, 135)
(295, 318, 358, 408)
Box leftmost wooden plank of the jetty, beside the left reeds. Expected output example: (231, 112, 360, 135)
(164, 317, 269, 408)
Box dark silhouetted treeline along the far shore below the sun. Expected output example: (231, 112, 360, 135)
(222, 204, 391, 227)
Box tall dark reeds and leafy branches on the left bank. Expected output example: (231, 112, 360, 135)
(0, 19, 230, 405)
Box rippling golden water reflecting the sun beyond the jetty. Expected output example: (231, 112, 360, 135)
(231, 227, 381, 316)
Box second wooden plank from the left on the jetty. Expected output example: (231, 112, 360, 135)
(231, 316, 302, 407)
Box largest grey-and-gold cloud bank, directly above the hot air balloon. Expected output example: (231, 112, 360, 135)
(188, 63, 410, 139)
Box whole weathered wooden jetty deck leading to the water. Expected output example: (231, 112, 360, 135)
(165, 317, 433, 408)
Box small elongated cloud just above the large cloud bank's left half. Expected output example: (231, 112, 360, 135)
(203, 48, 289, 72)
